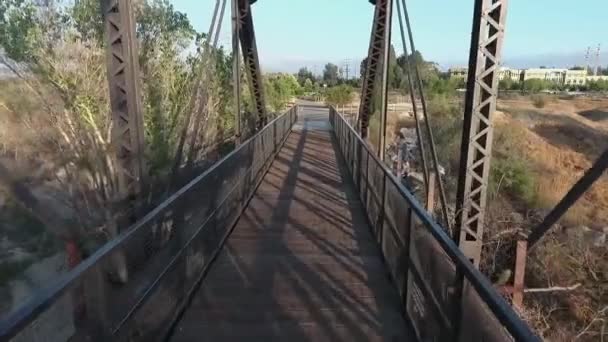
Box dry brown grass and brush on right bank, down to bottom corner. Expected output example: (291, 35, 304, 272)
(486, 99, 608, 341)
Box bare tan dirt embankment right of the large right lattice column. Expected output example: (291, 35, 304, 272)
(496, 96, 608, 228)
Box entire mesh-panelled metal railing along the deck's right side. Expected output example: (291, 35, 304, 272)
(329, 108, 540, 341)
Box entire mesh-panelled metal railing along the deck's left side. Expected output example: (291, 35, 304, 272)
(0, 107, 297, 341)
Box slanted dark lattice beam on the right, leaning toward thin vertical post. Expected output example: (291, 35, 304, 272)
(357, 0, 392, 139)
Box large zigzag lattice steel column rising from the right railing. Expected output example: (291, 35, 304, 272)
(454, 0, 508, 266)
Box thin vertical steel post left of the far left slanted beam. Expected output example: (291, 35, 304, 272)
(231, 0, 241, 146)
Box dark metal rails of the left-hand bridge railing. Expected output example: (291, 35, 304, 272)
(0, 107, 297, 341)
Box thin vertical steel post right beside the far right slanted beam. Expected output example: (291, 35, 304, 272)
(378, 0, 393, 162)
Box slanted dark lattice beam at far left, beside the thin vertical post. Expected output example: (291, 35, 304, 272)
(238, 0, 268, 129)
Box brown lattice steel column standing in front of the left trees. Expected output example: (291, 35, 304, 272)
(101, 0, 145, 200)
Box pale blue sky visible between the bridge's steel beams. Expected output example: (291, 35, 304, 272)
(171, 0, 608, 72)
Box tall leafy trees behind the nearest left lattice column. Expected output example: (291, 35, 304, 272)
(0, 0, 233, 280)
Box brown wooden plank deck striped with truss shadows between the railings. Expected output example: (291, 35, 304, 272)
(173, 107, 411, 341)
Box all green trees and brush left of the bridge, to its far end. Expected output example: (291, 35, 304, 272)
(0, 0, 302, 284)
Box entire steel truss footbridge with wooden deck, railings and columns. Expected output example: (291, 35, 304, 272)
(0, 0, 607, 341)
